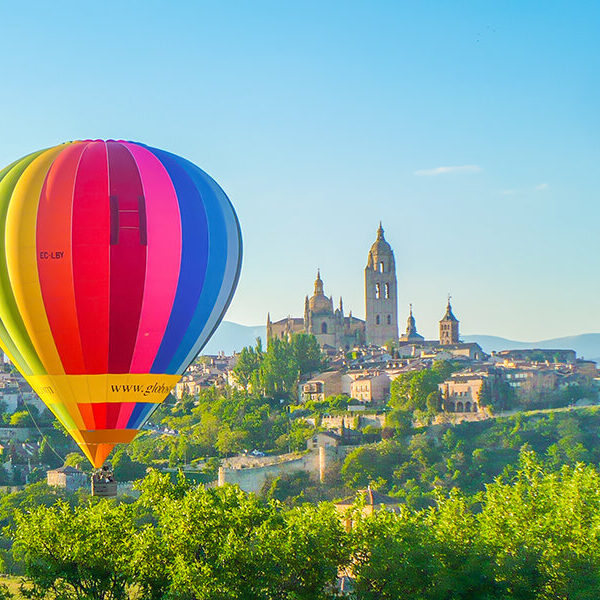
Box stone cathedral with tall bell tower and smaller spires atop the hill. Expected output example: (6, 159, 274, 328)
(267, 223, 459, 350)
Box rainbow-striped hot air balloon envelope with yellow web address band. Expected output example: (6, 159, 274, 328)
(0, 140, 242, 467)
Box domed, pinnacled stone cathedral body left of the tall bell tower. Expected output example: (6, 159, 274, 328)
(267, 271, 365, 349)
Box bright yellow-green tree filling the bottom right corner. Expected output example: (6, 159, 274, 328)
(479, 450, 600, 600)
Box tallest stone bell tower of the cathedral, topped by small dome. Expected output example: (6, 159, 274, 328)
(365, 223, 398, 346)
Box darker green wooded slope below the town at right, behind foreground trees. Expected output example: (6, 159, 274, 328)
(341, 407, 600, 508)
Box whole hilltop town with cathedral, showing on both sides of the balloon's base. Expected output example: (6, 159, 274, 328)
(0, 224, 600, 491)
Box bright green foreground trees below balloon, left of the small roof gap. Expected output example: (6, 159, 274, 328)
(14, 472, 349, 600)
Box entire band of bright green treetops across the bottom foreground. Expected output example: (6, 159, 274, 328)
(8, 451, 600, 600)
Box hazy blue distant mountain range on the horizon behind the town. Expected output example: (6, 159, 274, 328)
(202, 321, 600, 361)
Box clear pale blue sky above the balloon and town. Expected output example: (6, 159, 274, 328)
(0, 0, 600, 341)
